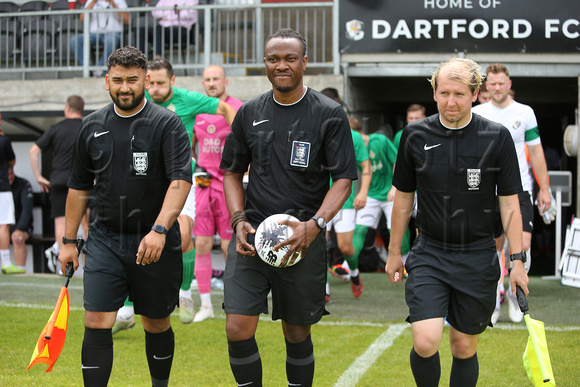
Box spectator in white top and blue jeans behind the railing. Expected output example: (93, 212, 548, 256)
(71, 0, 129, 77)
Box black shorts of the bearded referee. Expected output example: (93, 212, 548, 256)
(83, 222, 183, 319)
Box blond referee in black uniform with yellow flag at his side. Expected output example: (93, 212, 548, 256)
(386, 58, 528, 387)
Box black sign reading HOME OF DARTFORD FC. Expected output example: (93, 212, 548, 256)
(340, 0, 580, 53)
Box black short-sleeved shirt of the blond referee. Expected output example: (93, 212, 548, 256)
(393, 114, 522, 246)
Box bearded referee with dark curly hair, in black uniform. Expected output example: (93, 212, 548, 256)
(59, 46, 191, 386)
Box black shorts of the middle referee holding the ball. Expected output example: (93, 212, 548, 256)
(223, 234, 328, 325)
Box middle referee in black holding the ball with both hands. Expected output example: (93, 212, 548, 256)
(221, 29, 357, 386)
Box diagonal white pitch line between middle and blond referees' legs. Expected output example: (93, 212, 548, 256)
(334, 324, 409, 387)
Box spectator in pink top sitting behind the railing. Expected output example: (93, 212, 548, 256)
(139, 0, 199, 58)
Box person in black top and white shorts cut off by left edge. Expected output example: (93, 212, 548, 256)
(0, 135, 16, 274)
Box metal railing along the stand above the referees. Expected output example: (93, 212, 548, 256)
(0, 0, 340, 79)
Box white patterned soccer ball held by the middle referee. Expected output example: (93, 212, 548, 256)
(255, 214, 302, 267)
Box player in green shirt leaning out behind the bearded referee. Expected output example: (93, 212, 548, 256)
(113, 59, 236, 334)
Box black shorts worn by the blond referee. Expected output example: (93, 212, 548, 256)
(405, 235, 500, 335)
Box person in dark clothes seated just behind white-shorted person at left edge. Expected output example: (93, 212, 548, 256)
(8, 167, 34, 274)
